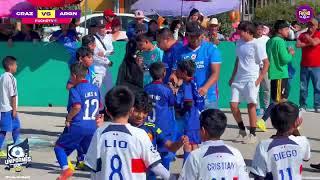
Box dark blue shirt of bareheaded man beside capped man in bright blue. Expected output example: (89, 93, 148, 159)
(162, 42, 183, 84)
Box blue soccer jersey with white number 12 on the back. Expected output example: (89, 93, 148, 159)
(67, 80, 101, 133)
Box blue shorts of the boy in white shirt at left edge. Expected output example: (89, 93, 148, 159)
(0, 111, 20, 132)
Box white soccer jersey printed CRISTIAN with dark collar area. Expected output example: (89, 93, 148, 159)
(180, 140, 249, 180)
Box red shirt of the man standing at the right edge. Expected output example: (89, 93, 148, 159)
(299, 31, 320, 67)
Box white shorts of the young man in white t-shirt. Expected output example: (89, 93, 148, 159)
(231, 81, 259, 104)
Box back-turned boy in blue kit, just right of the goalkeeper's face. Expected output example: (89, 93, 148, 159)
(144, 62, 175, 168)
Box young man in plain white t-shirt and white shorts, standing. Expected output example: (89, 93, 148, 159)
(229, 21, 269, 144)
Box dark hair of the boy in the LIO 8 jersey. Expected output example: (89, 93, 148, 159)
(105, 86, 134, 118)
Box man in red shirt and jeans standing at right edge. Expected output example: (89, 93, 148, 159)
(297, 19, 320, 113)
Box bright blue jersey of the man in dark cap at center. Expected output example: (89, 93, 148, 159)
(173, 41, 222, 102)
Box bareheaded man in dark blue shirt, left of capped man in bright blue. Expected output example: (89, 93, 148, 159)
(157, 28, 183, 84)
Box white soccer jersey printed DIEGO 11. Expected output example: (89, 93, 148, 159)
(251, 136, 310, 180)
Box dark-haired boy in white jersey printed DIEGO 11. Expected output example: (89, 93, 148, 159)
(251, 102, 310, 180)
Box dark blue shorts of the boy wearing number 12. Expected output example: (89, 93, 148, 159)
(56, 127, 93, 155)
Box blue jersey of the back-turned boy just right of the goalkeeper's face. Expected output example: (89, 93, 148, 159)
(145, 81, 175, 134)
